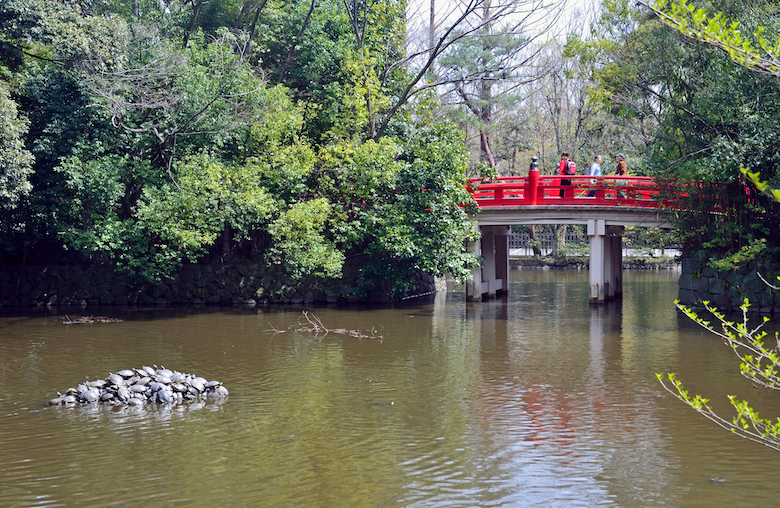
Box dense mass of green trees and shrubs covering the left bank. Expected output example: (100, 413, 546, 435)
(0, 0, 476, 298)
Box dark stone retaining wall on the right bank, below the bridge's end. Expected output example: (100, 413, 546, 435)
(677, 258, 780, 314)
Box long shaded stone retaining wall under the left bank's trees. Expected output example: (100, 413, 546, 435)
(0, 257, 437, 307)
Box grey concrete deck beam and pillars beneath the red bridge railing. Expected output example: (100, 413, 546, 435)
(466, 206, 672, 303)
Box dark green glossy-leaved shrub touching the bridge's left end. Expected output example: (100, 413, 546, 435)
(360, 123, 477, 290)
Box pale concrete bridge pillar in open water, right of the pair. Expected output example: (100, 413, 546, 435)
(588, 220, 623, 303)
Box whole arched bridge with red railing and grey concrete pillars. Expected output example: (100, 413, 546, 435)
(466, 175, 673, 303)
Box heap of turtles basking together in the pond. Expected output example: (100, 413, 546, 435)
(49, 365, 228, 406)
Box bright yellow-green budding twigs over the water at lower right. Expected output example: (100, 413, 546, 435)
(656, 299, 780, 451)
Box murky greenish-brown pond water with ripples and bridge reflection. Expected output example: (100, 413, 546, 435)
(0, 271, 780, 507)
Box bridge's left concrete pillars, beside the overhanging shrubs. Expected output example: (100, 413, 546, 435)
(466, 226, 512, 302)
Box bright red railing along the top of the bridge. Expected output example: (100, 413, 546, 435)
(467, 174, 671, 208)
